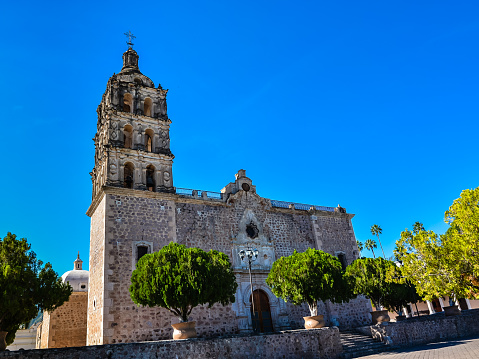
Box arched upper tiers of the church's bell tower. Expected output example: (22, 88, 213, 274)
(90, 43, 175, 199)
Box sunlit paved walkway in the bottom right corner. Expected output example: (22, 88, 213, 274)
(361, 336, 479, 359)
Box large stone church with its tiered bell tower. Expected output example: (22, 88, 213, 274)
(86, 47, 371, 345)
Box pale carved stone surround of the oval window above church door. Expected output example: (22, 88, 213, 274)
(232, 208, 275, 270)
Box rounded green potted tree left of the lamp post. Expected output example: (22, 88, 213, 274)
(130, 242, 238, 322)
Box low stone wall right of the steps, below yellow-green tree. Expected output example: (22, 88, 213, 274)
(362, 309, 479, 346)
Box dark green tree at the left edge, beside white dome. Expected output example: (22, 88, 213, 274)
(0, 232, 72, 348)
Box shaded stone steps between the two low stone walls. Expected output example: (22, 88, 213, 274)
(340, 330, 389, 359)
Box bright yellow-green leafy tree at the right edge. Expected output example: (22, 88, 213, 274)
(395, 187, 479, 300)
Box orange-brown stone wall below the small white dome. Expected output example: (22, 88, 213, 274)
(40, 292, 88, 349)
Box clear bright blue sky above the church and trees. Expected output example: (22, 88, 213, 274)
(0, 0, 479, 274)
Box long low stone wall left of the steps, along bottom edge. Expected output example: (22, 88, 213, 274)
(0, 327, 343, 359)
